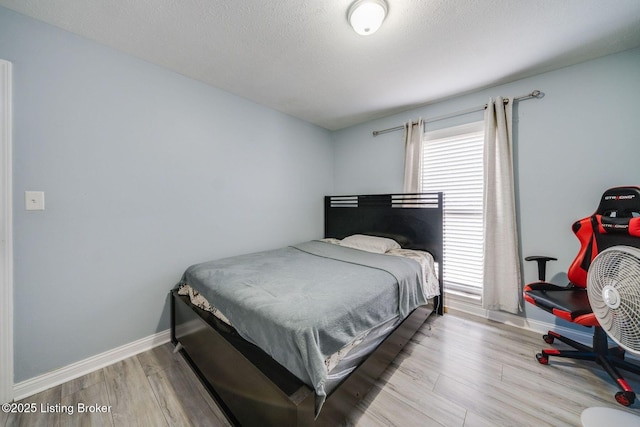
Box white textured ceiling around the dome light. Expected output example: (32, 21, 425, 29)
(0, 0, 640, 130)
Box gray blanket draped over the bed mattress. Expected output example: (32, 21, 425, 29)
(179, 241, 427, 413)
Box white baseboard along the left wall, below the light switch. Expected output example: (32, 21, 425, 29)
(13, 329, 171, 400)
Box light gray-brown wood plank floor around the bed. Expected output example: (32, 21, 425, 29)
(0, 314, 640, 427)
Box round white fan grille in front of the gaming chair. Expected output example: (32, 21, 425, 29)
(587, 246, 640, 354)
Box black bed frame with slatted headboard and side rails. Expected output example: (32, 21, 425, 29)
(171, 193, 444, 426)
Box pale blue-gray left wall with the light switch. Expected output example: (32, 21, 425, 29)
(0, 8, 333, 382)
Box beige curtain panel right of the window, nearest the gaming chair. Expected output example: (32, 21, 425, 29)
(482, 97, 522, 314)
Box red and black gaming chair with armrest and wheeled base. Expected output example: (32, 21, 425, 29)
(524, 187, 640, 406)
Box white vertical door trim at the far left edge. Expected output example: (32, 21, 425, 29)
(0, 59, 14, 403)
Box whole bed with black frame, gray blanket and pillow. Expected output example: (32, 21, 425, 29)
(171, 193, 443, 426)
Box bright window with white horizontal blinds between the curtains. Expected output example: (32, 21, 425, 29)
(420, 122, 484, 296)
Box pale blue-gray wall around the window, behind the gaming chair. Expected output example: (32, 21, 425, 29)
(333, 49, 640, 326)
